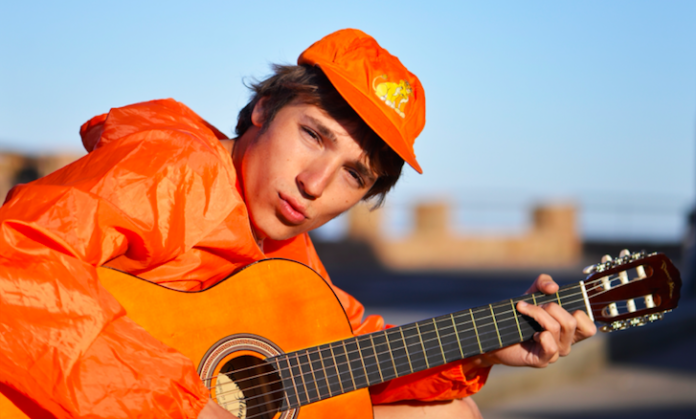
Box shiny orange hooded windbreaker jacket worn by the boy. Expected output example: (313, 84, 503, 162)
(0, 100, 488, 418)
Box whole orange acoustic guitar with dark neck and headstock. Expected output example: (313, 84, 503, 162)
(0, 252, 681, 419)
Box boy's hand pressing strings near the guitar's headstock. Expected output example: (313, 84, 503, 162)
(479, 275, 597, 368)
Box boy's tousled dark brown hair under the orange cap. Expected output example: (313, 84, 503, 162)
(235, 65, 404, 208)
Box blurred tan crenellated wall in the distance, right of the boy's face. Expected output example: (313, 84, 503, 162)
(348, 202, 582, 270)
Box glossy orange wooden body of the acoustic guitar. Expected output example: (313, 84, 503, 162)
(0, 259, 372, 419)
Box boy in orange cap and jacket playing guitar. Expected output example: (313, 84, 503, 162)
(0, 29, 594, 418)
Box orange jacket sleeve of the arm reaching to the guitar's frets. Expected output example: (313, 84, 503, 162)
(266, 234, 490, 404)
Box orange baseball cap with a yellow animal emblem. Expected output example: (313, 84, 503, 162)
(297, 29, 425, 173)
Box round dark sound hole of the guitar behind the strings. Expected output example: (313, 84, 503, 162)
(216, 355, 284, 419)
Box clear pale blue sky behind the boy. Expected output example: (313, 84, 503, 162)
(0, 0, 696, 240)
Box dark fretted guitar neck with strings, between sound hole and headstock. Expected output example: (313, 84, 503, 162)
(269, 282, 588, 408)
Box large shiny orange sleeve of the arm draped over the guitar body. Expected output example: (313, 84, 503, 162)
(0, 126, 239, 418)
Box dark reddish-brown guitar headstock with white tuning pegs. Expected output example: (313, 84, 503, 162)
(584, 250, 681, 332)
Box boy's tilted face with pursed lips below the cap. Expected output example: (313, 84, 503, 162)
(234, 102, 377, 240)
